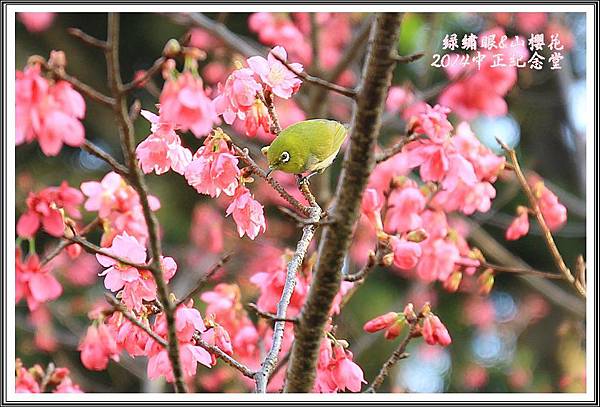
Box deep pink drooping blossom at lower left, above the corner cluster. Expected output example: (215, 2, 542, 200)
(78, 323, 119, 370)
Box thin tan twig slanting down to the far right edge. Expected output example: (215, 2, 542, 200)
(496, 138, 586, 297)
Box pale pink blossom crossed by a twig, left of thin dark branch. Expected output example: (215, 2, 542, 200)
(96, 232, 146, 292)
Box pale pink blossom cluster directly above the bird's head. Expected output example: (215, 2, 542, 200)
(214, 46, 303, 136)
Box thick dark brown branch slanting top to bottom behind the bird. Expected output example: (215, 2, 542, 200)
(284, 13, 401, 393)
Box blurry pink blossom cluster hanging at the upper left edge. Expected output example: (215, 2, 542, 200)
(15, 58, 85, 156)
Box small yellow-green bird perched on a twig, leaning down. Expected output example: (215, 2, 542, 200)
(261, 119, 348, 180)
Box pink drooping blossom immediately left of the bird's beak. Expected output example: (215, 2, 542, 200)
(185, 130, 240, 198)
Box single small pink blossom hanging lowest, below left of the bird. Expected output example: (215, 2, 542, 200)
(227, 186, 267, 240)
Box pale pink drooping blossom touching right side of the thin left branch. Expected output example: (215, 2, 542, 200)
(135, 110, 192, 175)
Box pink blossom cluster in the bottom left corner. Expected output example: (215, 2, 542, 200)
(15, 359, 83, 393)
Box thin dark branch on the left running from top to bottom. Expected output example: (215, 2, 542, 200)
(106, 13, 186, 392)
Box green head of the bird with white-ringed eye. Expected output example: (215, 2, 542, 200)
(262, 137, 308, 174)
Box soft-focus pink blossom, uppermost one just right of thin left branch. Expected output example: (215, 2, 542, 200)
(160, 71, 219, 137)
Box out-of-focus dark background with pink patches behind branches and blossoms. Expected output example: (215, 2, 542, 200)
(16, 13, 587, 392)
